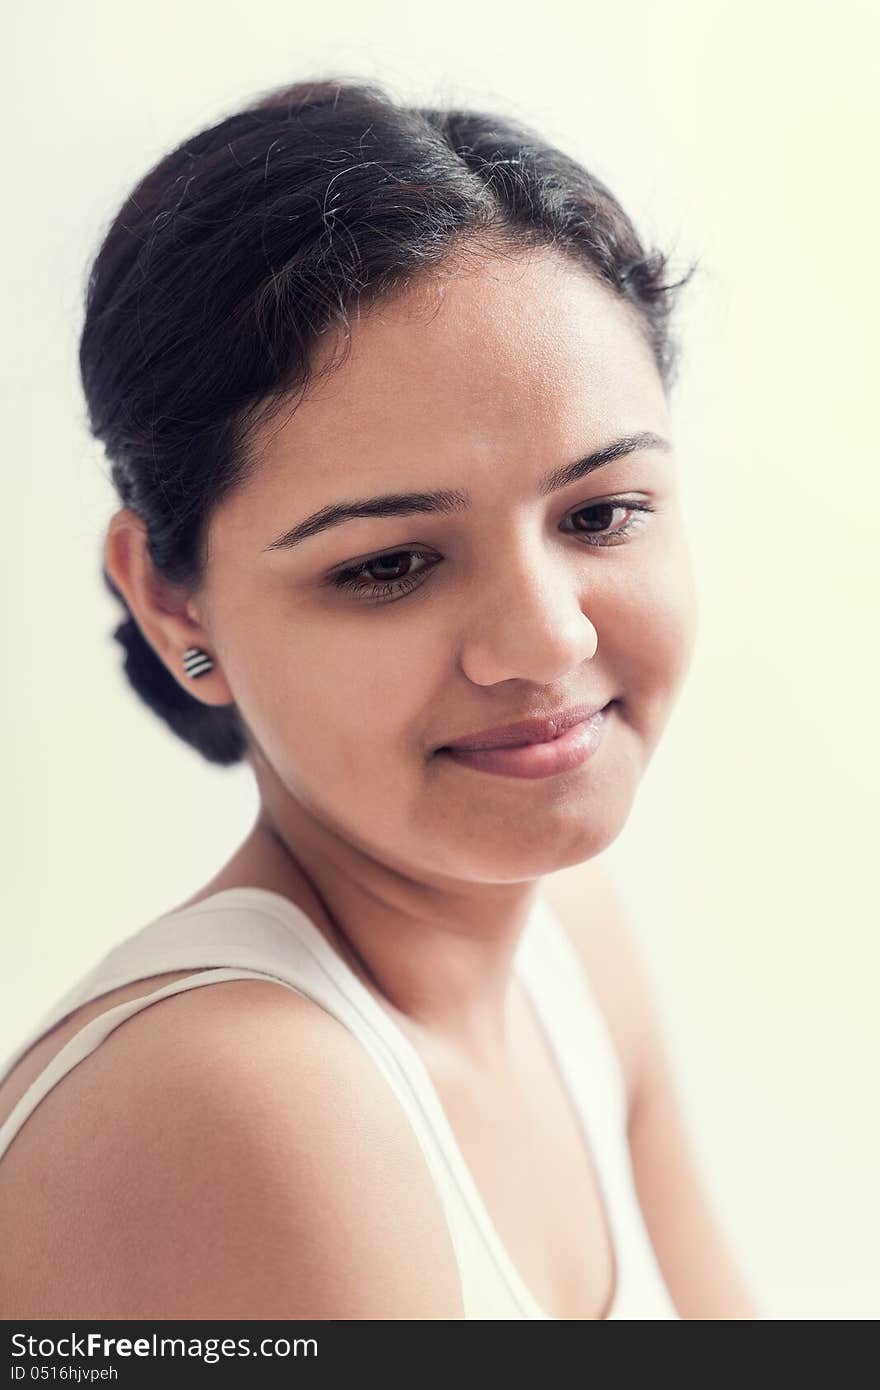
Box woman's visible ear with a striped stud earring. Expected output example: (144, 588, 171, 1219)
(104, 507, 234, 705)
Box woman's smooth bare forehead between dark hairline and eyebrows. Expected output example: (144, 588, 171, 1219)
(226, 249, 669, 520)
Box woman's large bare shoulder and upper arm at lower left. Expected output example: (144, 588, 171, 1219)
(0, 980, 463, 1319)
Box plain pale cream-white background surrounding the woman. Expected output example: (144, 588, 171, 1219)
(0, 0, 880, 1319)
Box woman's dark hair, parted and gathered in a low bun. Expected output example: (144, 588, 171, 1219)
(79, 79, 696, 765)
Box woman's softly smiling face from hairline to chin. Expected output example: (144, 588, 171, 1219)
(195, 252, 695, 883)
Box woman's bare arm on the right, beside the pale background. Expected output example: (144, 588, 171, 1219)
(550, 863, 760, 1319)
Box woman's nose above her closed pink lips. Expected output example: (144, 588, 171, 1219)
(459, 546, 599, 685)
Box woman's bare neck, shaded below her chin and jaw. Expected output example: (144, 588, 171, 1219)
(236, 805, 535, 1069)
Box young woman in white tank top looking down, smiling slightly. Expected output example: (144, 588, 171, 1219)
(0, 82, 758, 1319)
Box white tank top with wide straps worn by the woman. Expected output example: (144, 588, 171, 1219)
(0, 888, 678, 1321)
